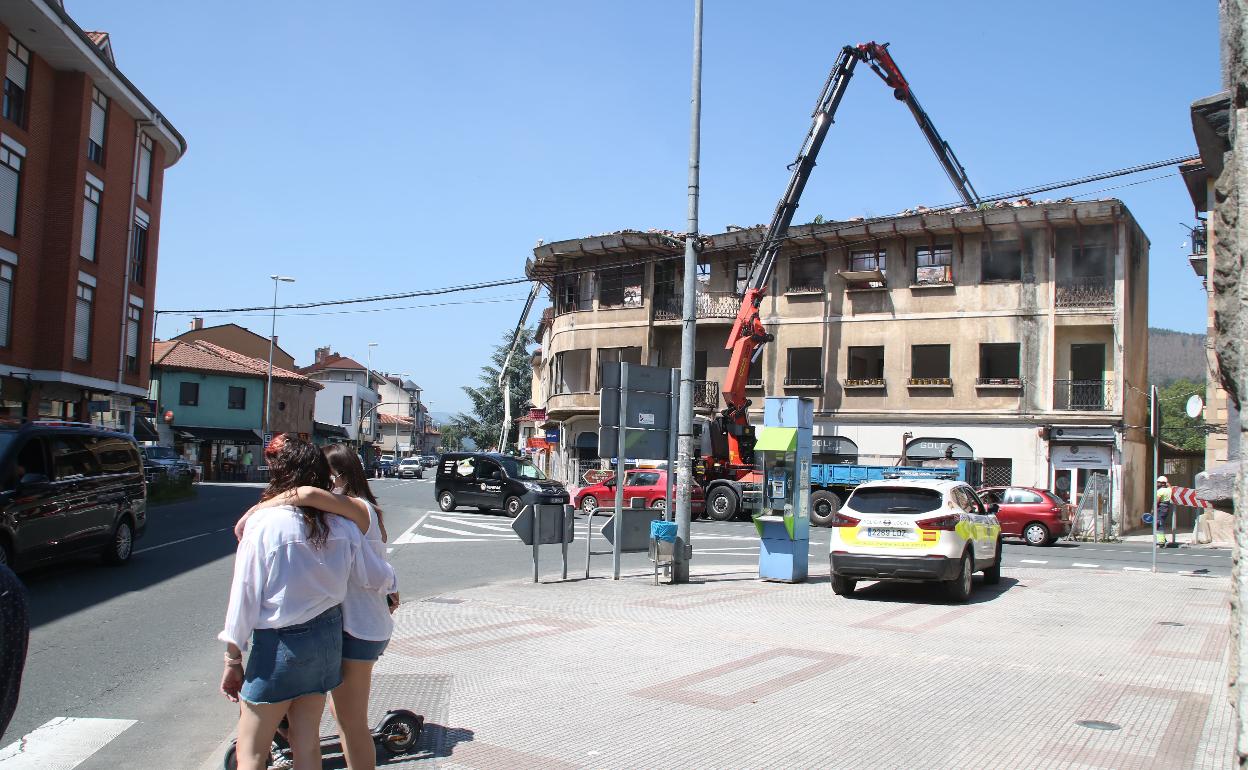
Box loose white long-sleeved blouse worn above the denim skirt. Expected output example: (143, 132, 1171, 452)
(217, 505, 398, 650)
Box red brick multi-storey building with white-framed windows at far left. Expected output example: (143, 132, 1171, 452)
(0, 0, 186, 432)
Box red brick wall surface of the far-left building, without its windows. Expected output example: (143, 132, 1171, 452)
(0, 6, 185, 422)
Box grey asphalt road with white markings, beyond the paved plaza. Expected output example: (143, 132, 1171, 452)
(0, 479, 1231, 770)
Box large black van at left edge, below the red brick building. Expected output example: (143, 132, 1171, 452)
(0, 421, 147, 569)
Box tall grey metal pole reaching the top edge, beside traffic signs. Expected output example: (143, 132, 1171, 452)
(671, 0, 703, 583)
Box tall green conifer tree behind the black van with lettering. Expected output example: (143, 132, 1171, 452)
(442, 328, 533, 449)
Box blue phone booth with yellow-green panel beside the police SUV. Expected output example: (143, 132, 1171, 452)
(754, 397, 815, 583)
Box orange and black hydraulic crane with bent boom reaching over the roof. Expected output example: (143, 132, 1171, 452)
(700, 42, 980, 519)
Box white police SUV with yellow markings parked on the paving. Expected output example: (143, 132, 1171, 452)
(829, 478, 1001, 602)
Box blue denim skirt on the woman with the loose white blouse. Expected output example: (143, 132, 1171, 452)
(240, 605, 342, 703)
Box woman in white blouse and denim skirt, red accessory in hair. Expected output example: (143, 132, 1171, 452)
(218, 436, 397, 770)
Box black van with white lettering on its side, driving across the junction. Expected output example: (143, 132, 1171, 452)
(433, 452, 568, 517)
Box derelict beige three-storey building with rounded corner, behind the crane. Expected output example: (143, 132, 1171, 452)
(528, 200, 1149, 533)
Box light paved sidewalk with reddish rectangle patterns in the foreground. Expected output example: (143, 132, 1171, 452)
(207, 564, 1233, 770)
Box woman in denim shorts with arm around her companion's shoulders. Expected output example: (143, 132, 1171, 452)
(235, 444, 399, 770)
